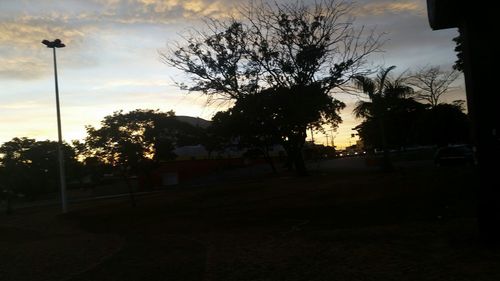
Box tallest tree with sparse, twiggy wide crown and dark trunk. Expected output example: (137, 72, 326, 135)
(161, 0, 380, 173)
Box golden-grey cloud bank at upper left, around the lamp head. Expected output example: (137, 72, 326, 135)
(0, 0, 242, 80)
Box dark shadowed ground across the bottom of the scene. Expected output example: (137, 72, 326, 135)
(0, 163, 500, 281)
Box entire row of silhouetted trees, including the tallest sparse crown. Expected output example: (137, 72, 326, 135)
(0, 0, 467, 206)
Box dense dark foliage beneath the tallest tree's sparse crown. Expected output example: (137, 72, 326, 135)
(208, 85, 344, 169)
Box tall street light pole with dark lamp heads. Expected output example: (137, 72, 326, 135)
(42, 39, 68, 213)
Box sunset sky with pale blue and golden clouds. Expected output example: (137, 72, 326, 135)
(0, 0, 465, 147)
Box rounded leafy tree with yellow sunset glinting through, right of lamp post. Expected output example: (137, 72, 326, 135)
(85, 109, 203, 168)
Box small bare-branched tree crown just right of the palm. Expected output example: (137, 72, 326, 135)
(407, 66, 460, 107)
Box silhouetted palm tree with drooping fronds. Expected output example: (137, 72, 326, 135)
(353, 66, 414, 170)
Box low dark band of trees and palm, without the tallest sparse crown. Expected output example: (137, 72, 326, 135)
(0, 67, 470, 208)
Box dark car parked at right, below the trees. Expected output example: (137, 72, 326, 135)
(434, 145, 476, 166)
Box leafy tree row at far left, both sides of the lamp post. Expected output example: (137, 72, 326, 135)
(0, 109, 206, 202)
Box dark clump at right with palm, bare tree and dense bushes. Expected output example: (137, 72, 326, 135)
(354, 67, 470, 152)
